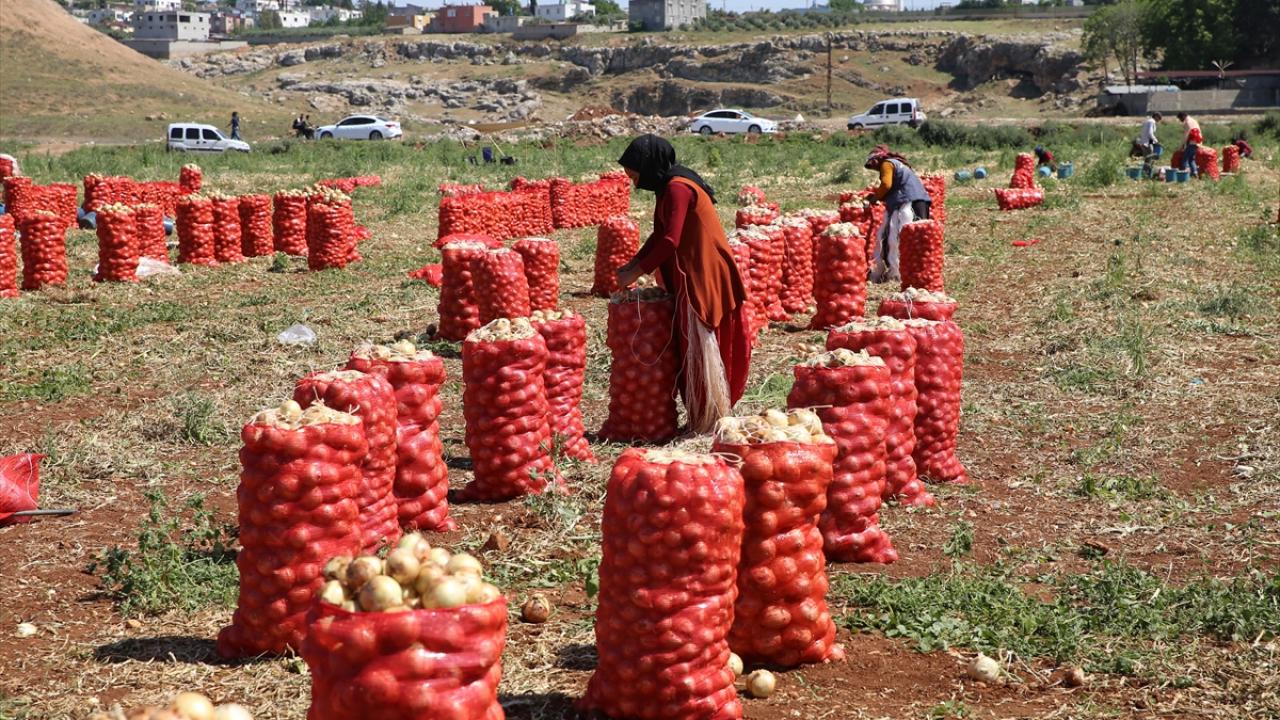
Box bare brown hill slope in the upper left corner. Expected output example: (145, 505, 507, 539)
(0, 0, 288, 141)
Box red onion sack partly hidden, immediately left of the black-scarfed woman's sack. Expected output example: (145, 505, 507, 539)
(530, 310, 595, 462)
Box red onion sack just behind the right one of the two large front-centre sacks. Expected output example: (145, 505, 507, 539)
(787, 350, 897, 564)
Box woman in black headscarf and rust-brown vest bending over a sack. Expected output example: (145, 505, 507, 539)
(617, 135, 751, 433)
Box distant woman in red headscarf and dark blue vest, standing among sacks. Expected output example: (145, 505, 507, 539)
(864, 145, 932, 283)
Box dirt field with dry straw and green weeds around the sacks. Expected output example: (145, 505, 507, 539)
(0, 130, 1280, 720)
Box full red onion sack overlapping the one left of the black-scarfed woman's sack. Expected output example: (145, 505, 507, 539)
(460, 318, 564, 502)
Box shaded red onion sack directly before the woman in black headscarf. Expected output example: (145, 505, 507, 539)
(596, 287, 678, 442)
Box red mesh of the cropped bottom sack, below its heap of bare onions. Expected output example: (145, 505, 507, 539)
(301, 598, 507, 720)
